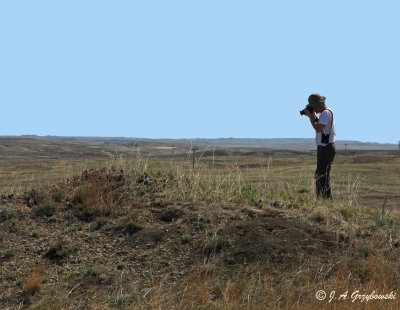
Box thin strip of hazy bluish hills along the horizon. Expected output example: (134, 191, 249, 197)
(0, 135, 398, 150)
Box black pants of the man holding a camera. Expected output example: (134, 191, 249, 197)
(315, 143, 336, 199)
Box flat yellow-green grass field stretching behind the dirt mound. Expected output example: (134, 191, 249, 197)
(0, 151, 400, 207)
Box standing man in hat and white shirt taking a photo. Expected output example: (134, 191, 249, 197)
(302, 94, 336, 199)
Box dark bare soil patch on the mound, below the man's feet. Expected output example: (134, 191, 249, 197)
(220, 209, 342, 264)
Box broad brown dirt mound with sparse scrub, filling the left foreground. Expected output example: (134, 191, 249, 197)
(0, 168, 341, 307)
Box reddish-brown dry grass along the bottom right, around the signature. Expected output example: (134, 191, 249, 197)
(136, 247, 400, 310)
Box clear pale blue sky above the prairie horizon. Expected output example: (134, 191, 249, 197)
(0, 0, 400, 143)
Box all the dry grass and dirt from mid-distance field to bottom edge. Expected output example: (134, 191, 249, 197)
(0, 144, 400, 309)
